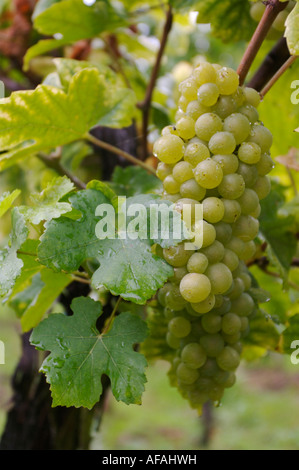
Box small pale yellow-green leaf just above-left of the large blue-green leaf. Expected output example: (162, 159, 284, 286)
(19, 176, 74, 225)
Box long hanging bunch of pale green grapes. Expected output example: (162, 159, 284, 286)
(154, 63, 273, 408)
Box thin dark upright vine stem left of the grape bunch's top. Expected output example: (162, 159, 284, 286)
(137, 6, 173, 159)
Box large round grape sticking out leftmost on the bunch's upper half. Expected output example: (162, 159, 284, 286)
(153, 134, 184, 163)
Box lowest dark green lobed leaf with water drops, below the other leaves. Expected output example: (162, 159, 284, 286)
(31, 297, 147, 409)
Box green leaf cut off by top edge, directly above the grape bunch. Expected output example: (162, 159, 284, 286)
(196, 0, 256, 42)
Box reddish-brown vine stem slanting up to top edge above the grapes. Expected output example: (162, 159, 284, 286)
(237, 0, 287, 86)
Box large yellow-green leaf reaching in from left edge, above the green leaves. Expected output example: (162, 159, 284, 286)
(0, 68, 137, 170)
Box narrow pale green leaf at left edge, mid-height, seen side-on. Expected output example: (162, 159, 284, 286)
(0, 207, 29, 297)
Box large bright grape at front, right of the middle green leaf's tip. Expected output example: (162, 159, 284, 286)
(180, 273, 211, 303)
